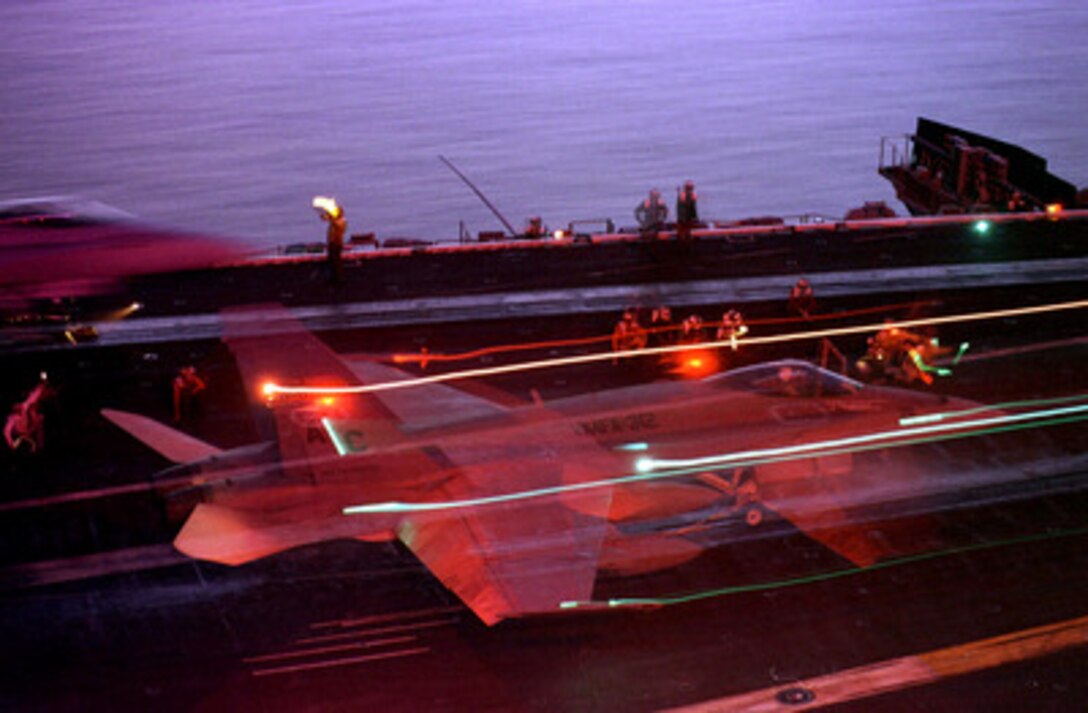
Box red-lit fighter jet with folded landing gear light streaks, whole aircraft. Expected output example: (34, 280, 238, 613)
(103, 306, 1084, 625)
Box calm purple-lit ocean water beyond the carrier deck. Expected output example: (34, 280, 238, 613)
(0, 0, 1088, 251)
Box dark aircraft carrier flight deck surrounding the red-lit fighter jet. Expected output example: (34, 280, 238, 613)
(0, 132, 1088, 711)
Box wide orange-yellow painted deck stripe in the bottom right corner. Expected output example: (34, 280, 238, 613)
(669, 616, 1088, 713)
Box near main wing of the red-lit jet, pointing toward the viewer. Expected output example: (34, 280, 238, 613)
(335, 411, 617, 625)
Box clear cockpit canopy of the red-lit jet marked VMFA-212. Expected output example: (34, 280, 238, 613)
(705, 359, 865, 398)
